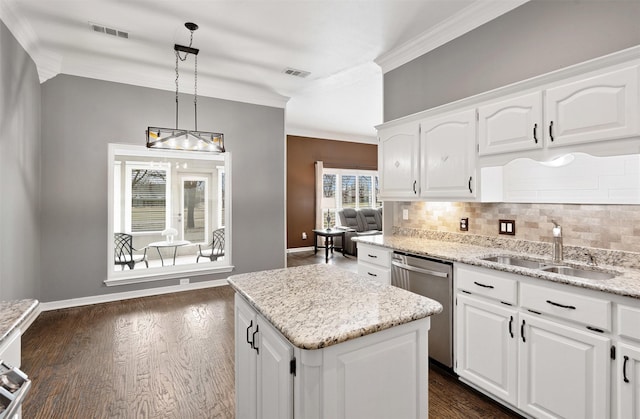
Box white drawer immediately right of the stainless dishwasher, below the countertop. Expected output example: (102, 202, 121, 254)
(456, 268, 518, 305)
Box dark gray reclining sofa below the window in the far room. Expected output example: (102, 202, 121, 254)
(335, 208, 382, 256)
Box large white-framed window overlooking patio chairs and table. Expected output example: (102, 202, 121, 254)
(105, 144, 231, 285)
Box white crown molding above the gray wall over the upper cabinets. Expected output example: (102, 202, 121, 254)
(374, 0, 529, 74)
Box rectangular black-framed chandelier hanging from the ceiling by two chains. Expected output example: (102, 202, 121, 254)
(147, 22, 225, 153)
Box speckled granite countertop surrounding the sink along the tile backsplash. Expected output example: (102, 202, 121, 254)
(355, 234, 640, 299)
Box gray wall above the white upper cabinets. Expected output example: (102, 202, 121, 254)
(384, 0, 640, 121)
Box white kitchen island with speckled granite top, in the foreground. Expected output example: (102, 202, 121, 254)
(229, 265, 442, 419)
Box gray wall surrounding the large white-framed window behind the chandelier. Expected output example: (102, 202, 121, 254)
(40, 75, 285, 301)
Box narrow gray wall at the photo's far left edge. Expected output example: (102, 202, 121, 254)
(0, 22, 40, 300)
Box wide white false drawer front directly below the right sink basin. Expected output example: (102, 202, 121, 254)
(520, 284, 611, 331)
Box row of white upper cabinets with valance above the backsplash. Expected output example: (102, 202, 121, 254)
(378, 46, 640, 204)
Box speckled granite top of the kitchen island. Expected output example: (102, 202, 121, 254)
(228, 265, 442, 349)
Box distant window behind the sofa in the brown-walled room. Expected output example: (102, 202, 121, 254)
(321, 169, 382, 228)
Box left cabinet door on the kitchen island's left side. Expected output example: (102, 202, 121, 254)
(234, 294, 257, 419)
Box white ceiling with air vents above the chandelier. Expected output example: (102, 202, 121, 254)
(0, 0, 527, 142)
